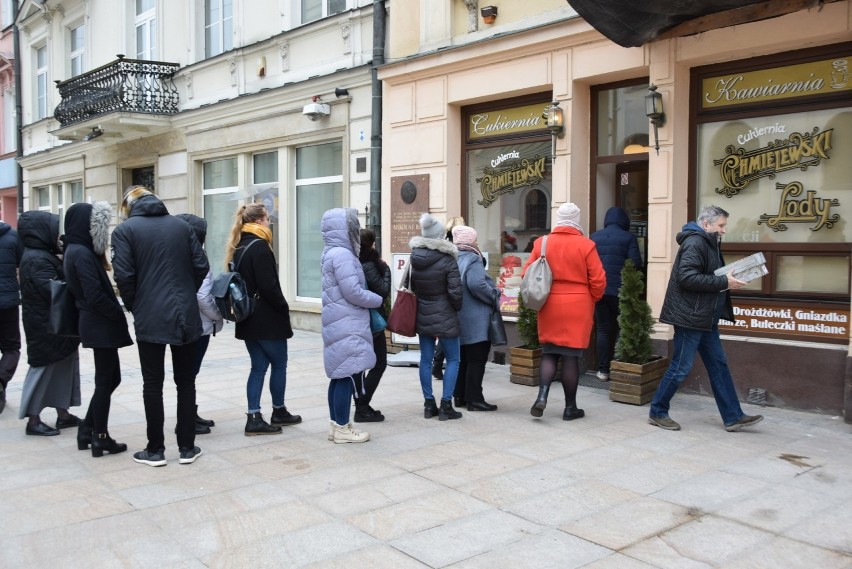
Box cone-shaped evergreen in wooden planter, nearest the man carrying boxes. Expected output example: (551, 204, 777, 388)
(609, 259, 669, 405)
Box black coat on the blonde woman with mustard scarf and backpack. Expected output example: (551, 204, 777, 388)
(234, 232, 293, 340)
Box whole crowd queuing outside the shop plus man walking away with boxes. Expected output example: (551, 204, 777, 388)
(0, 197, 762, 466)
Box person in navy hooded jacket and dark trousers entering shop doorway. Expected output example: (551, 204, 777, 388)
(589, 207, 642, 381)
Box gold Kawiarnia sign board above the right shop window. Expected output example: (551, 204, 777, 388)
(701, 54, 852, 109)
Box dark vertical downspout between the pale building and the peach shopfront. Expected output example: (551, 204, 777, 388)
(367, 0, 387, 251)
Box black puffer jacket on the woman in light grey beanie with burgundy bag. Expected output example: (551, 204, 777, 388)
(408, 236, 462, 338)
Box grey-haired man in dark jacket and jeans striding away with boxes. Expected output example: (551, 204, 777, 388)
(648, 206, 763, 431)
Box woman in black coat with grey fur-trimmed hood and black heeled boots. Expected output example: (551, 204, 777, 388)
(63, 201, 133, 457)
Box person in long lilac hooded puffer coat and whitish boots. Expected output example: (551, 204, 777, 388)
(321, 208, 382, 443)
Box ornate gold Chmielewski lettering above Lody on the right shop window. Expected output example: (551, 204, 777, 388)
(713, 124, 834, 197)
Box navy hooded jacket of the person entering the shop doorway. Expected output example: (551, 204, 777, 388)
(589, 207, 642, 296)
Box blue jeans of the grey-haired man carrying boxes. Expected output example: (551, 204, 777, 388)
(650, 321, 744, 426)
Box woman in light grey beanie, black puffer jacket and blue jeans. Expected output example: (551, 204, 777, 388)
(410, 213, 462, 421)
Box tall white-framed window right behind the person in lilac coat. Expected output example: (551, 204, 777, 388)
(296, 142, 343, 298)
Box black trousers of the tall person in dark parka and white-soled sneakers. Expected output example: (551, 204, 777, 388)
(136, 340, 196, 452)
